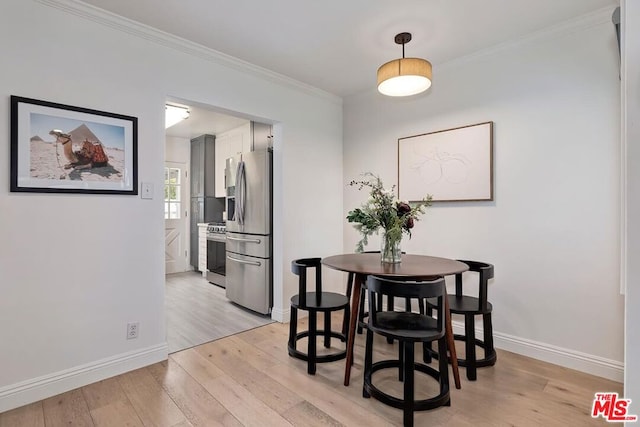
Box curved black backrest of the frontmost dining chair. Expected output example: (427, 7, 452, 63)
(367, 276, 446, 333)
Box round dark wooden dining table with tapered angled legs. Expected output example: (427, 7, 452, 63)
(322, 253, 469, 389)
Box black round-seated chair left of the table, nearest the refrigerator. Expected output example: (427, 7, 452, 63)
(287, 258, 349, 375)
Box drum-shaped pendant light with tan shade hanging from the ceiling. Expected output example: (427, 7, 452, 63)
(378, 33, 431, 96)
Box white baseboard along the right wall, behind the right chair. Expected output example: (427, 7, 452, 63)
(453, 321, 624, 382)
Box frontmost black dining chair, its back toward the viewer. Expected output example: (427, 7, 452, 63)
(362, 276, 451, 426)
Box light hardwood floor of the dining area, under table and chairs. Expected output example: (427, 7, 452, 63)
(0, 312, 622, 427)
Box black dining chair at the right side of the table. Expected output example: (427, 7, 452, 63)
(449, 260, 497, 381)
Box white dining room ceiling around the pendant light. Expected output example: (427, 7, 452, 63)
(84, 0, 619, 97)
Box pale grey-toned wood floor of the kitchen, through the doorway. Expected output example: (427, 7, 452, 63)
(165, 271, 272, 353)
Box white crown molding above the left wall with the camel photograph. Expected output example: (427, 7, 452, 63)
(35, 0, 342, 105)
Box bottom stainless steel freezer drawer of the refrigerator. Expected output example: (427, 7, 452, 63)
(226, 252, 273, 314)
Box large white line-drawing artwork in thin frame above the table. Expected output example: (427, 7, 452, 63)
(398, 122, 493, 201)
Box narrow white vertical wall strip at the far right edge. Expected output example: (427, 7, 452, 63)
(622, 0, 640, 408)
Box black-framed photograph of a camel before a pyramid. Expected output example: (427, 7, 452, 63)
(10, 96, 138, 195)
